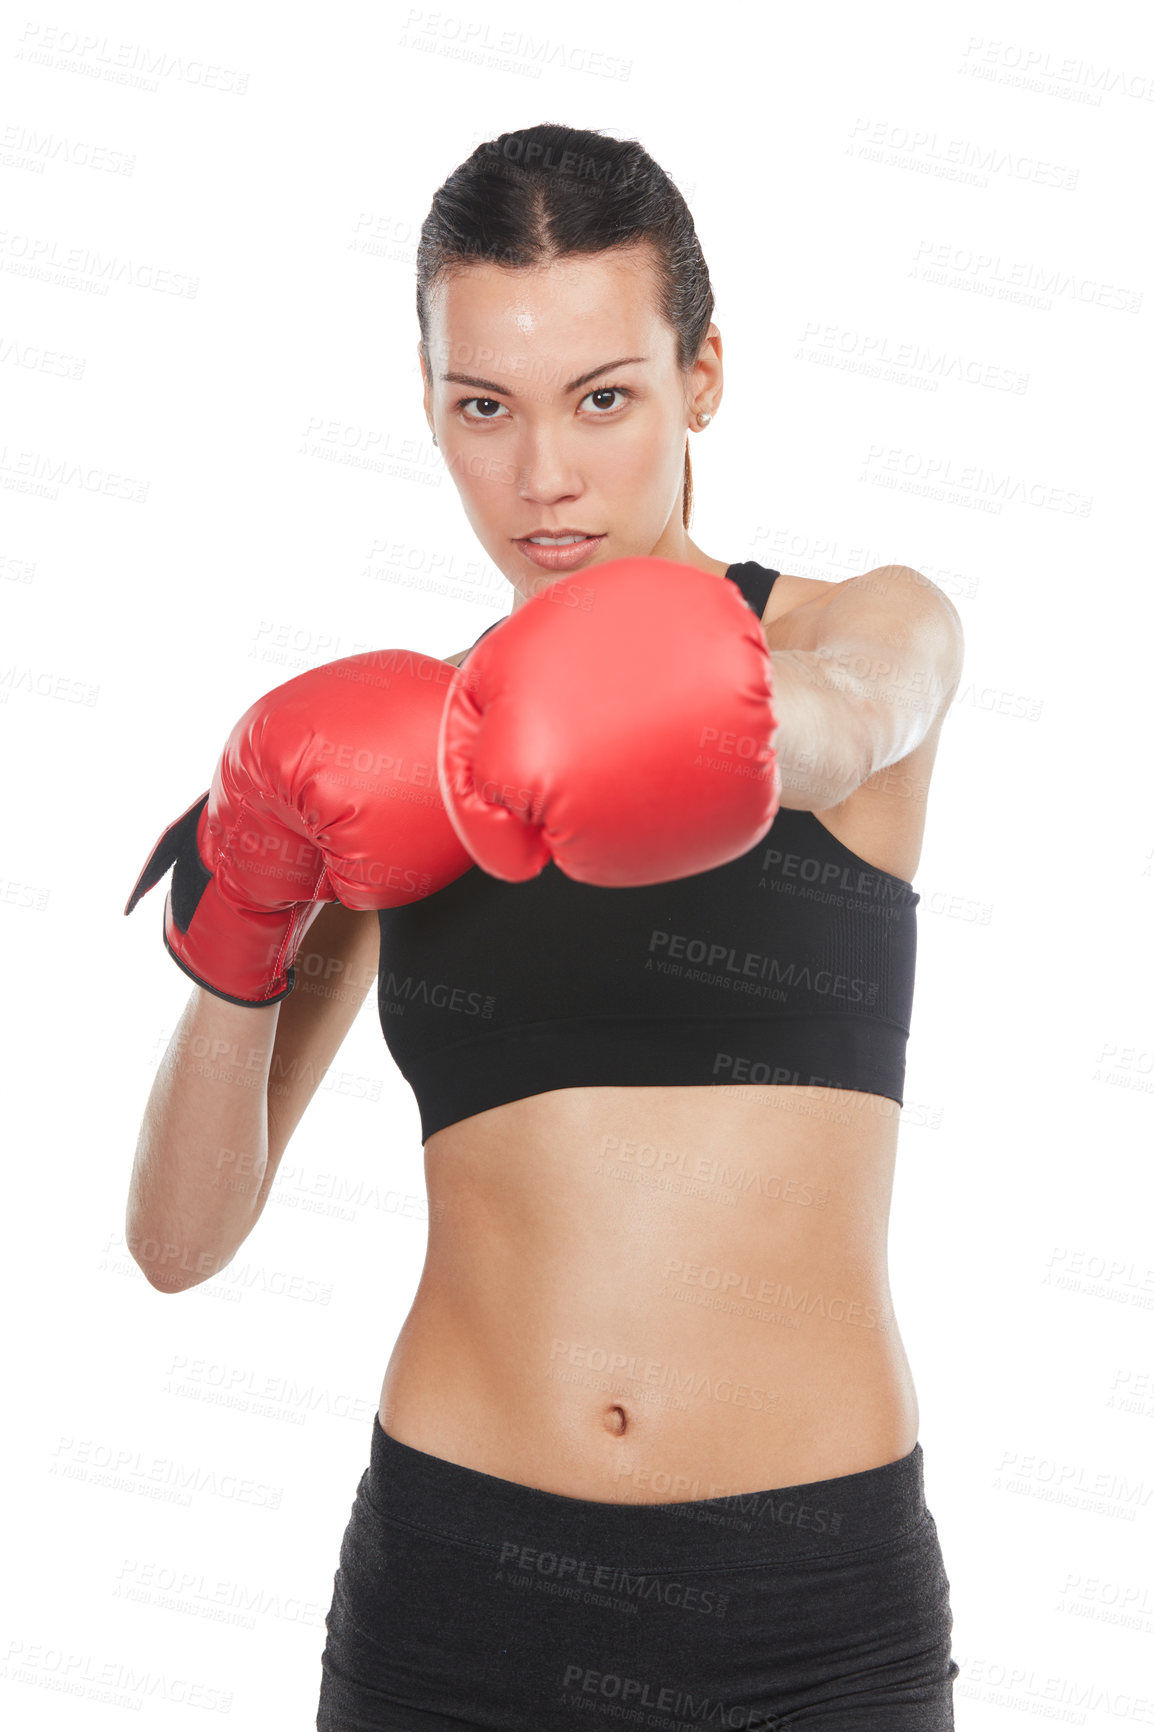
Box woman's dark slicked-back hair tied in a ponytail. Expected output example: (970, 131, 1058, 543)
(416, 123, 714, 528)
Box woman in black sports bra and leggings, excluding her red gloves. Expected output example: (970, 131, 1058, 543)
(130, 125, 962, 1732)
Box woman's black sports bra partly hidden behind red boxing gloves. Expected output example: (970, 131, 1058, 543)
(378, 559, 920, 1141)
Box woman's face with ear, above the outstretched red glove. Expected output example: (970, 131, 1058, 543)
(421, 248, 721, 610)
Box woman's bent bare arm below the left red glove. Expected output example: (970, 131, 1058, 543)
(125, 902, 379, 1292)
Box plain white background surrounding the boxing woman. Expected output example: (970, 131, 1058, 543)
(0, 0, 1154, 1732)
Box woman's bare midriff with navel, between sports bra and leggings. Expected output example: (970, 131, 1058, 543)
(379, 1086, 918, 1502)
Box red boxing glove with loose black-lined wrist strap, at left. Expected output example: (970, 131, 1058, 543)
(125, 650, 473, 1005)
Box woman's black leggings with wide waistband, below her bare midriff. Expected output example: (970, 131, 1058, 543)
(317, 1415, 958, 1732)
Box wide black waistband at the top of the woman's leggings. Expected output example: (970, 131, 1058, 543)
(367, 1413, 925, 1571)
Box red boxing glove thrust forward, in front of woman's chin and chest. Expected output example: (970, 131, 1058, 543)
(437, 558, 781, 887)
